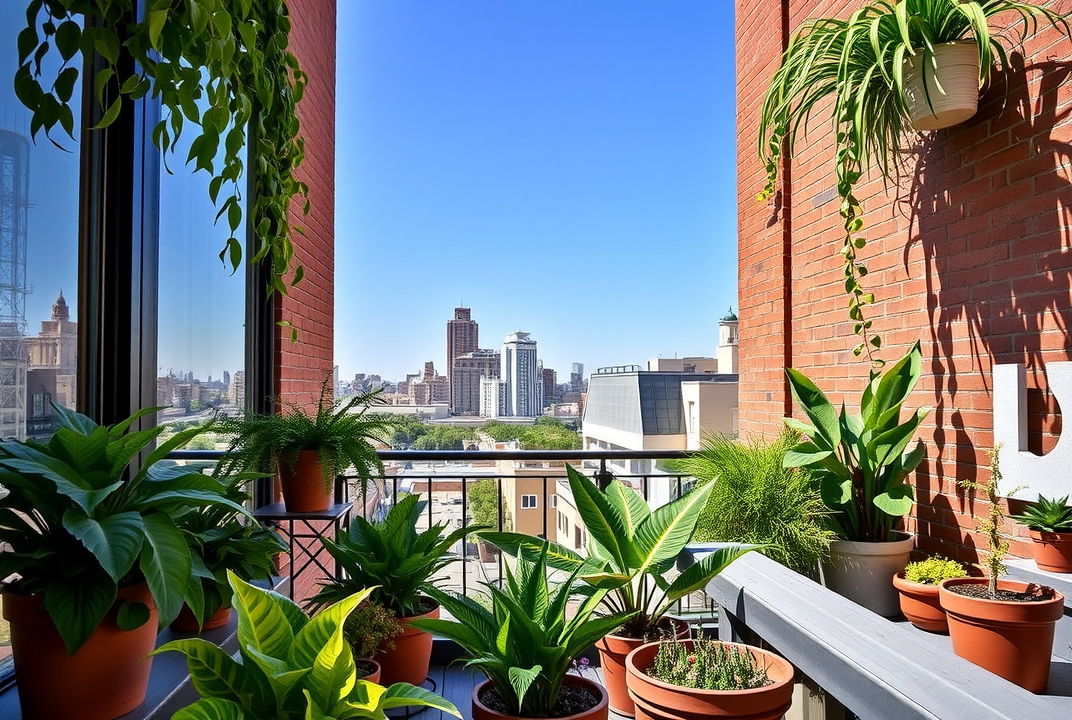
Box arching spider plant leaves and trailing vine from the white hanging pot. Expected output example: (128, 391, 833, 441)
(759, 0, 1070, 366)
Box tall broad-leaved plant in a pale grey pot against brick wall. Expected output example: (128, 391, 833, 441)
(783, 342, 930, 617)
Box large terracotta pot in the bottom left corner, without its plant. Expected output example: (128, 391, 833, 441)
(3, 583, 160, 720)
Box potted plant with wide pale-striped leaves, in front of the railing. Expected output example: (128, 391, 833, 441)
(480, 465, 757, 716)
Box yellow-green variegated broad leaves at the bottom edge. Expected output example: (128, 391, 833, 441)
(153, 573, 462, 720)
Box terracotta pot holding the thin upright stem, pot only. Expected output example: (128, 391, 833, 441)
(938, 578, 1064, 692)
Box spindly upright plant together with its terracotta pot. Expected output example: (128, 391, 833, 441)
(938, 446, 1064, 692)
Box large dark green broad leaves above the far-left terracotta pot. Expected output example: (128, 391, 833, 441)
(0, 404, 245, 653)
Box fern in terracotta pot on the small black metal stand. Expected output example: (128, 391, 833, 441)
(219, 378, 389, 513)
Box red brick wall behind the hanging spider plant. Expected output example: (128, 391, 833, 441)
(736, 0, 1072, 560)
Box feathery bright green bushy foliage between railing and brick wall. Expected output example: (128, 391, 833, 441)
(673, 431, 835, 575)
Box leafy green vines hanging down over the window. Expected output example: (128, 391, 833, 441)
(15, 0, 309, 295)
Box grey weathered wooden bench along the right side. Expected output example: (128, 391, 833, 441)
(706, 553, 1072, 720)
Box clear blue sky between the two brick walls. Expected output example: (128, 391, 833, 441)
(336, 0, 736, 378)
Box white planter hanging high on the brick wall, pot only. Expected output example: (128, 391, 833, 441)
(904, 41, 979, 131)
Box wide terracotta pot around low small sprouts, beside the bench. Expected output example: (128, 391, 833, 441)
(626, 640, 794, 720)
